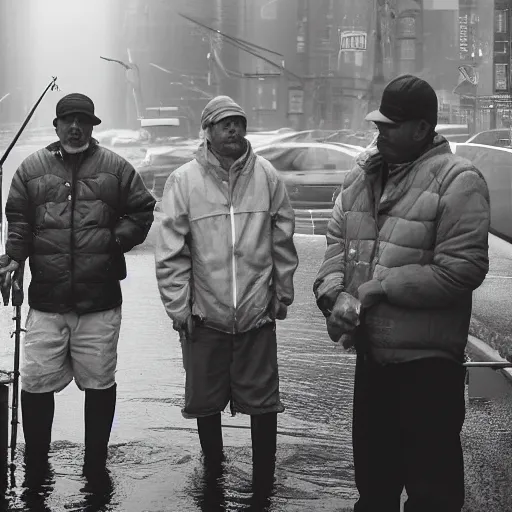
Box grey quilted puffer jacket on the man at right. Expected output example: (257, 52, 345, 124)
(314, 136, 490, 363)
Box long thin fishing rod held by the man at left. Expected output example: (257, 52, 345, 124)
(0, 76, 59, 482)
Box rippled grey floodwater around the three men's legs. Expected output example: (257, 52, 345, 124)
(0, 138, 512, 512)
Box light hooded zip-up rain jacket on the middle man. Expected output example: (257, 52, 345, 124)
(155, 141, 298, 334)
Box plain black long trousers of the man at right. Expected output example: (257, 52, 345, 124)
(352, 356, 465, 512)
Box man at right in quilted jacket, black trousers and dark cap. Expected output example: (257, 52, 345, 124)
(314, 75, 490, 512)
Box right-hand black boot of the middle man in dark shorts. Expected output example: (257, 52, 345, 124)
(251, 412, 277, 497)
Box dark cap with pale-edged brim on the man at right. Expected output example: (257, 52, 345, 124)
(366, 75, 438, 127)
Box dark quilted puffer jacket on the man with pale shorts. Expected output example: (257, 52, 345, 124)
(5, 140, 155, 314)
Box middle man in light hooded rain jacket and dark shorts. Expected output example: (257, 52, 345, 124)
(156, 96, 298, 487)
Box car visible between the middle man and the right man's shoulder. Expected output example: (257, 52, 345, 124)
(256, 142, 359, 210)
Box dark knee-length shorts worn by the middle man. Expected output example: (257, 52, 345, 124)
(182, 323, 284, 418)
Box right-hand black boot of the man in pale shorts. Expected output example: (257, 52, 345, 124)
(83, 384, 117, 492)
